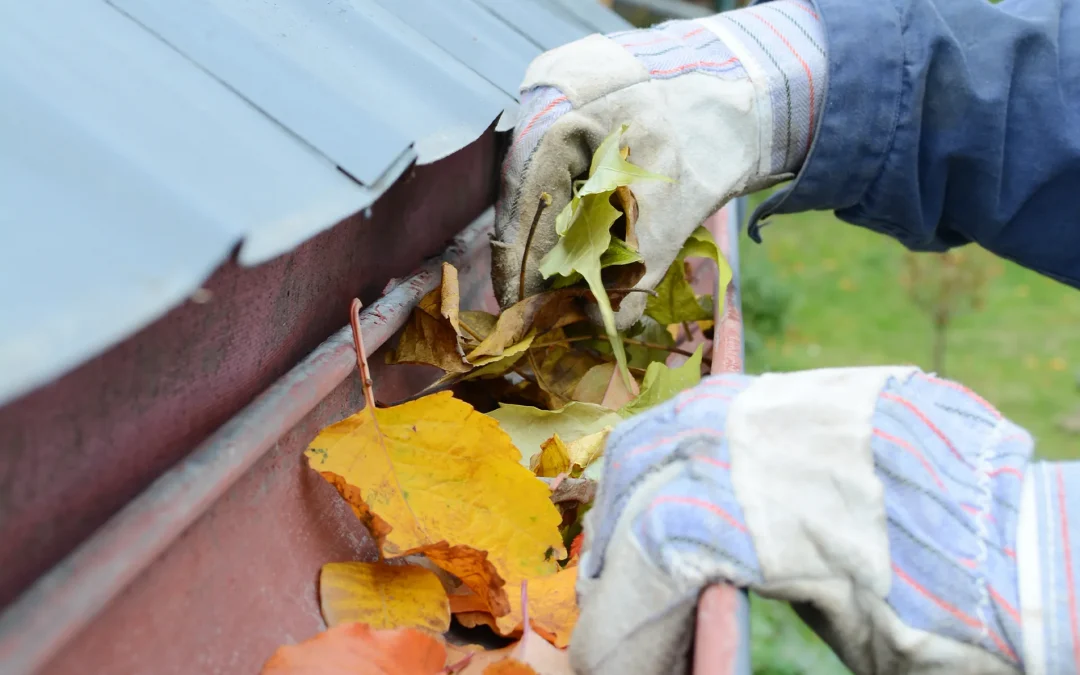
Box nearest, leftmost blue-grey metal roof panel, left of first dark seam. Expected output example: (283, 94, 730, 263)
(0, 0, 376, 402)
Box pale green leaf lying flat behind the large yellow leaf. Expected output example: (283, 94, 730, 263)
(488, 402, 622, 467)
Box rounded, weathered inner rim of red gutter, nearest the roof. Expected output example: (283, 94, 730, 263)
(0, 208, 494, 675)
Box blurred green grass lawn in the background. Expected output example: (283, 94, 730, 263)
(740, 208, 1080, 675)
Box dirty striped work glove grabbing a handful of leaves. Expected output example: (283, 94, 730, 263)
(491, 0, 826, 328)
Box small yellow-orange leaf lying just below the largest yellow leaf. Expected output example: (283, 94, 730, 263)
(319, 563, 450, 633)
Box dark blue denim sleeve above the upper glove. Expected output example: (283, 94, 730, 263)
(751, 0, 1080, 287)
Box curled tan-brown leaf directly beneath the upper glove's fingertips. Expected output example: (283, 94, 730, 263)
(468, 288, 591, 363)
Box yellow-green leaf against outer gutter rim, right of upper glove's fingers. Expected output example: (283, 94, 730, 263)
(645, 226, 731, 326)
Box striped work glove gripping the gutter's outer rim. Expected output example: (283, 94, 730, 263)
(570, 367, 1080, 675)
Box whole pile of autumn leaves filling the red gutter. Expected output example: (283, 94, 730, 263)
(264, 126, 730, 675)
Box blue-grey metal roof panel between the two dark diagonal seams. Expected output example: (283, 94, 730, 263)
(109, 0, 509, 166)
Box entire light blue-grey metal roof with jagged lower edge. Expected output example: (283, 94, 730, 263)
(0, 0, 626, 404)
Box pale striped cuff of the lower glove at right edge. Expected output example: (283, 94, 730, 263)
(1017, 462, 1080, 675)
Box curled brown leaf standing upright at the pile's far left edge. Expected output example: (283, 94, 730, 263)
(387, 262, 472, 373)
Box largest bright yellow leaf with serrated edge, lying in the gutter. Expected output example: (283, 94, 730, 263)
(306, 392, 565, 580)
